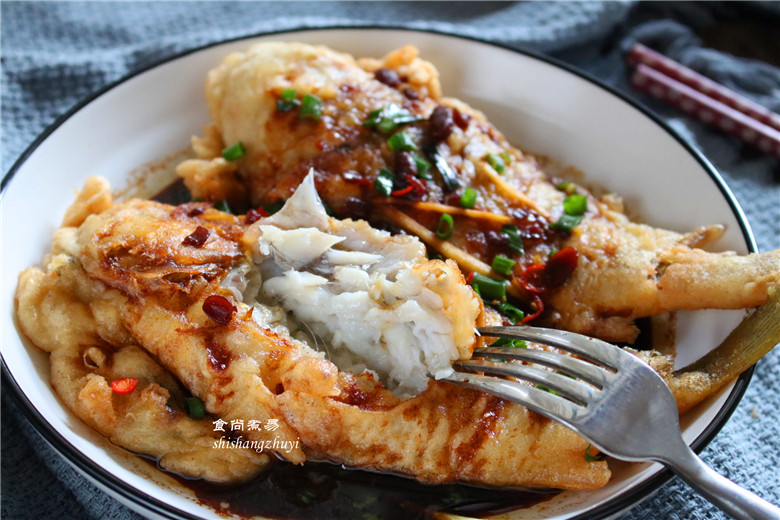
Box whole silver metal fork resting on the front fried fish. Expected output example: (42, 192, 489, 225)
(444, 327, 780, 520)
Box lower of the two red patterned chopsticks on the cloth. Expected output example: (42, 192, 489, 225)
(631, 64, 780, 157)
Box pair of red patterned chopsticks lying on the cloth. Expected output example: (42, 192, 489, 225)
(626, 43, 780, 157)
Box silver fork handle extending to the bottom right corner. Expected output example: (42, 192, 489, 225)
(664, 446, 780, 520)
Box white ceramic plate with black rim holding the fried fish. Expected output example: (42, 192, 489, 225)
(1, 29, 754, 519)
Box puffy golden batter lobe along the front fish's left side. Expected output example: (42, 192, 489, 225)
(16, 179, 270, 483)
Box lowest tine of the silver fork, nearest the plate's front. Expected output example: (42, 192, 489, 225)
(440, 372, 585, 428)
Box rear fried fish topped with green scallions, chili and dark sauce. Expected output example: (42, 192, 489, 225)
(178, 43, 780, 342)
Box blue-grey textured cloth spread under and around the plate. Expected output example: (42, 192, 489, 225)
(2, 2, 780, 520)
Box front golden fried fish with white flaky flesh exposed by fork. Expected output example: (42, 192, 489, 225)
(18, 177, 610, 489)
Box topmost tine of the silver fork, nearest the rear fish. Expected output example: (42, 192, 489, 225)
(477, 327, 623, 370)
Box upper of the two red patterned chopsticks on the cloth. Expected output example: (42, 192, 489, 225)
(626, 43, 780, 130)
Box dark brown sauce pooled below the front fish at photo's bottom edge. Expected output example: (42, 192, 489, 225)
(175, 462, 556, 520)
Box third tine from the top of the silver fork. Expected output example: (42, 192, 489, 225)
(455, 359, 595, 406)
